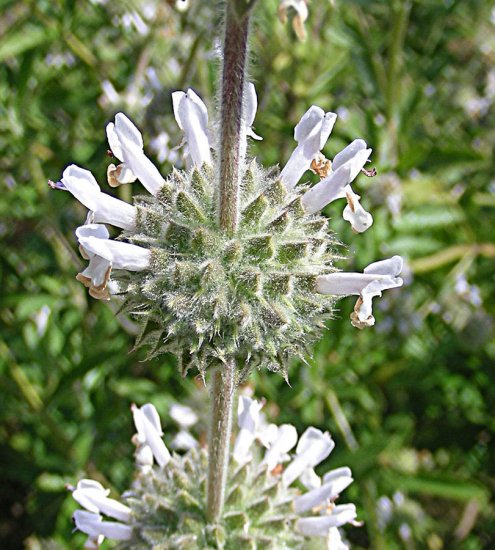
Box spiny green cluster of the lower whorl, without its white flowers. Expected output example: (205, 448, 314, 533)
(118, 449, 314, 550)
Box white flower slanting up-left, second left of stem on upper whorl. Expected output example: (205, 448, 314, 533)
(112, 113, 165, 195)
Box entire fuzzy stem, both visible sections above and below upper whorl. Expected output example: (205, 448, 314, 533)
(207, 0, 256, 523)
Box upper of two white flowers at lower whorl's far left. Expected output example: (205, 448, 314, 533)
(72, 479, 131, 523)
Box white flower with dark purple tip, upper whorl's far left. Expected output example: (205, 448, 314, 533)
(60, 164, 136, 229)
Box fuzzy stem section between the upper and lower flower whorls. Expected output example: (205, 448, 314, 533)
(207, 360, 235, 523)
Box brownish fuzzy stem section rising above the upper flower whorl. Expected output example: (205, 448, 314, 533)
(218, 0, 254, 235)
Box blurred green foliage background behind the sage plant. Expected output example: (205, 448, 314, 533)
(0, 0, 495, 550)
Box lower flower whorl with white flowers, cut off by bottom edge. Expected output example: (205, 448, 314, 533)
(70, 396, 356, 550)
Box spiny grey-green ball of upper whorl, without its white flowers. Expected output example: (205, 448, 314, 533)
(115, 160, 338, 379)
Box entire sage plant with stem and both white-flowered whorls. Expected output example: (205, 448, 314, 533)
(51, 0, 402, 549)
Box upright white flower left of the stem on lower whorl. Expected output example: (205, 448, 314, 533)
(131, 403, 170, 468)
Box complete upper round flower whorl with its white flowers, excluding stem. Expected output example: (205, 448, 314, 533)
(52, 84, 402, 379)
